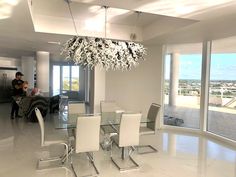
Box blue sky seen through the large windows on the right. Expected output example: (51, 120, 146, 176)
(165, 53, 236, 80)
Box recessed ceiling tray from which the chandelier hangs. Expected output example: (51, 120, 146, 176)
(31, 0, 198, 41)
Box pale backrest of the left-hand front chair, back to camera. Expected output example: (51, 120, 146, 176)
(75, 115, 101, 153)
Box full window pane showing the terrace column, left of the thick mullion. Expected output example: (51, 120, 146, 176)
(164, 44, 202, 128)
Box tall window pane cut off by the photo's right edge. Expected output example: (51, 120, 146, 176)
(207, 40, 236, 140)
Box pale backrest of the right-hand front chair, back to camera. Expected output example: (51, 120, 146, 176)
(119, 113, 142, 147)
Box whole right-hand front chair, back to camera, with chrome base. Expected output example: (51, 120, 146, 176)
(111, 113, 142, 171)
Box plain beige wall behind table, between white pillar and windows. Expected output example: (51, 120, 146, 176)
(106, 46, 163, 121)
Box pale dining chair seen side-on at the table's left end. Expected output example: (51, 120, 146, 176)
(35, 107, 68, 170)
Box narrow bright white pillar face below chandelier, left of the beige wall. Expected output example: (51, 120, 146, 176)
(94, 67, 106, 113)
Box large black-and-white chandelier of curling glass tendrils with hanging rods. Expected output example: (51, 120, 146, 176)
(61, 0, 146, 70)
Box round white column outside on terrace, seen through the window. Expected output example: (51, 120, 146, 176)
(169, 53, 179, 106)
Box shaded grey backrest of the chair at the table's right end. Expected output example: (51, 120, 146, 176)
(147, 103, 161, 131)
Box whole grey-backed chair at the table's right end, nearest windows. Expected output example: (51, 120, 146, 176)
(138, 103, 161, 154)
